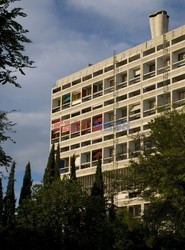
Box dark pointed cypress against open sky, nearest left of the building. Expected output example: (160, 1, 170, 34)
(19, 162, 32, 205)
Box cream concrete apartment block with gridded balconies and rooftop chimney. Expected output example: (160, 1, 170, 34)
(51, 11, 185, 216)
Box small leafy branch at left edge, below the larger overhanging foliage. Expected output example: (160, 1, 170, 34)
(0, 111, 15, 167)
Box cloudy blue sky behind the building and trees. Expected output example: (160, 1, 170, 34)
(0, 0, 185, 199)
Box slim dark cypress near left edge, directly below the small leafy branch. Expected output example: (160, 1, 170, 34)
(4, 162, 16, 229)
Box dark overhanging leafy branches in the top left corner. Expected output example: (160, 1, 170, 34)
(0, 0, 34, 87)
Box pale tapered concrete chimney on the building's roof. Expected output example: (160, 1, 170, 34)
(149, 10, 169, 38)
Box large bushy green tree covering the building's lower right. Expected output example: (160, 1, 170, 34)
(125, 110, 185, 249)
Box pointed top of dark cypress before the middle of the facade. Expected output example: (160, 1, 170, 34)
(91, 158, 104, 199)
